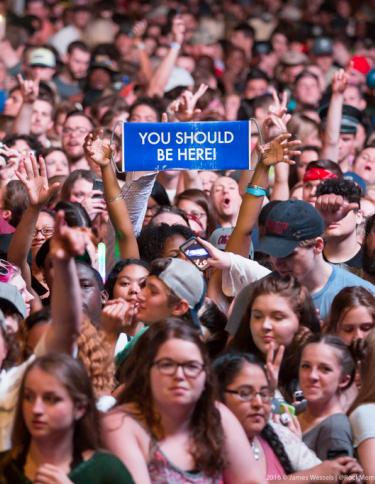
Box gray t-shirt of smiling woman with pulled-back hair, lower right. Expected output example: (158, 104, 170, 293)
(302, 413, 353, 460)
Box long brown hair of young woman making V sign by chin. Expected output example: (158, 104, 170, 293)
(229, 273, 320, 400)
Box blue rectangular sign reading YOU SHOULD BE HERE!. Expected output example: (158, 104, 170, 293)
(122, 121, 251, 171)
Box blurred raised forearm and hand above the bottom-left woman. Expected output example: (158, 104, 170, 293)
(45, 212, 86, 353)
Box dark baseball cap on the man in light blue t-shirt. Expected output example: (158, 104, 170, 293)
(257, 200, 324, 257)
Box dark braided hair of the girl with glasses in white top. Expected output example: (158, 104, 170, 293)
(213, 353, 295, 474)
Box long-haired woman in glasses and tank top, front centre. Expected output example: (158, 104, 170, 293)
(103, 319, 262, 484)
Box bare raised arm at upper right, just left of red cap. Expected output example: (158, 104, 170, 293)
(321, 69, 348, 162)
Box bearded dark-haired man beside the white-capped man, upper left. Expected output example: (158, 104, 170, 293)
(54, 41, 90, 100)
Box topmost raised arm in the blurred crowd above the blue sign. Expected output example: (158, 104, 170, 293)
(147, 16, 185, 96)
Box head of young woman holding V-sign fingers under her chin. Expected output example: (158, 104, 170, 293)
(231, 274, 319, 401)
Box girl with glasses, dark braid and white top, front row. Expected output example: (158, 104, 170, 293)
(213, 353, 362, 482)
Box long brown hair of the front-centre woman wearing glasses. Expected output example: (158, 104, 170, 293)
(119, 318, 224, 475)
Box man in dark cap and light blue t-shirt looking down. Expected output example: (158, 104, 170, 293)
(225, 200, 375, 334)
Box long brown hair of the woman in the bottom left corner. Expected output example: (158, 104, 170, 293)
(12, 353, 100, 453)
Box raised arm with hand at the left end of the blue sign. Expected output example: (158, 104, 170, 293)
(84, 130, 139, 259)
